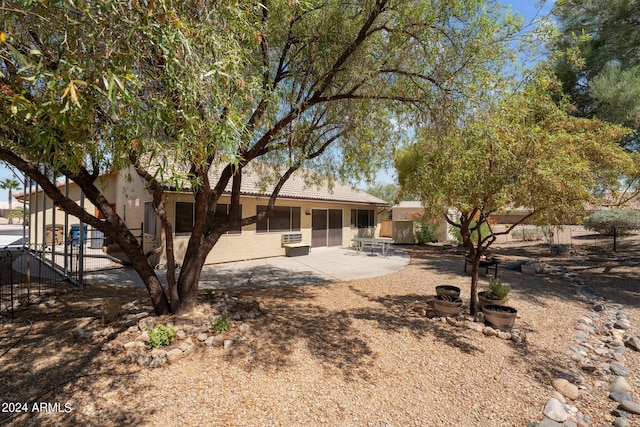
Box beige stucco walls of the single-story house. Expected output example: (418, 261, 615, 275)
(25, 172, 380, 264)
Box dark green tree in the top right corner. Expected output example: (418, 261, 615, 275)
(553, 0, 640, 131)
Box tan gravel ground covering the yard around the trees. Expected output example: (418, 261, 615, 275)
(0, 245, 640, 427)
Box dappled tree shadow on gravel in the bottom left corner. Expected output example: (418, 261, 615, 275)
(0, 288, 153, 426)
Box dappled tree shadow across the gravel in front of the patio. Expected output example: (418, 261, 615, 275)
(225, 285, 483, 380)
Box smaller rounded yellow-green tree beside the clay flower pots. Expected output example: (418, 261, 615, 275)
(396, 66, 629, 313)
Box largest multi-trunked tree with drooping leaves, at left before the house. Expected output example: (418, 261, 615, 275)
(0, 0, 521, 313)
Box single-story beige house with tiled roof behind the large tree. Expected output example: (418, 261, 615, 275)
(19, 163, 388, 264)
